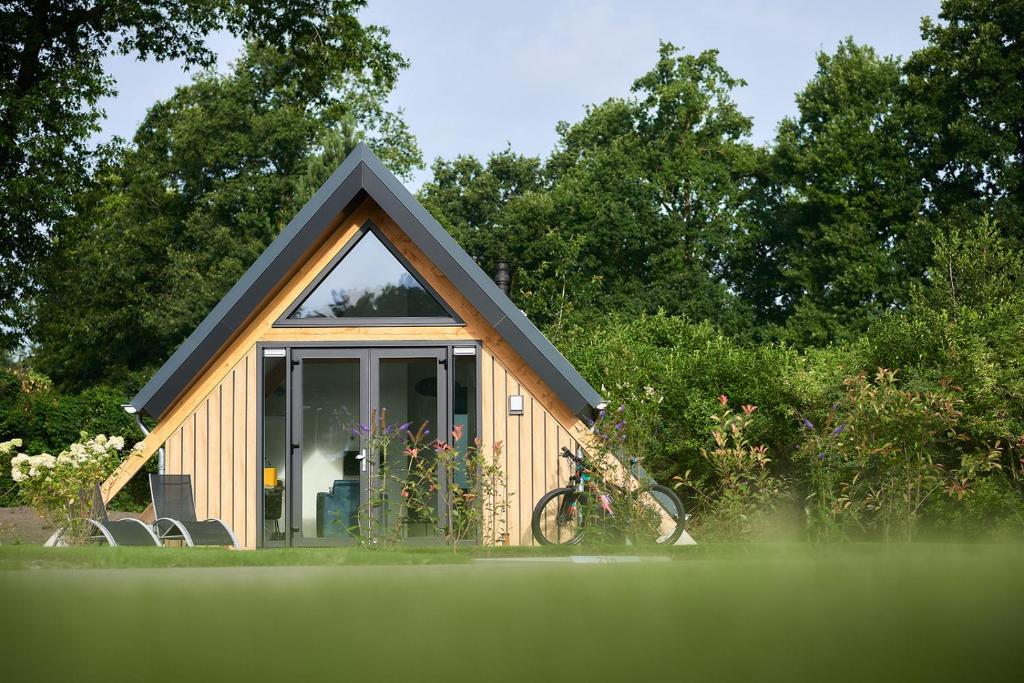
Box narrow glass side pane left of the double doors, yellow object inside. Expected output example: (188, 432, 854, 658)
(263, 357, 288, 543)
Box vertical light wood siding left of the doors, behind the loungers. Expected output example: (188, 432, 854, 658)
(164, 346, 259, 548)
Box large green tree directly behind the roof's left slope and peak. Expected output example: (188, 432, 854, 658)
(33, 31, 420, 389)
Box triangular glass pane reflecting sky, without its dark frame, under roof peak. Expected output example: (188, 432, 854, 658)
(289, 231, 449, 319)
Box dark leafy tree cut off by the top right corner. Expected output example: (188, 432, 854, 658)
(905, 0, 1024, 240)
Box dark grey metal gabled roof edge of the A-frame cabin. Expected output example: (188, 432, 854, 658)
(131, 143, 601, 419)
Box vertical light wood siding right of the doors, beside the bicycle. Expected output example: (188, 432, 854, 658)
(480, 347, 577, 546)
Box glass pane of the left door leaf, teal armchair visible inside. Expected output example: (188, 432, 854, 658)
(301, 358, 361, 539)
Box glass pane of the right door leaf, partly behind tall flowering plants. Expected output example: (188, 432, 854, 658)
(379, 357, 443, 537)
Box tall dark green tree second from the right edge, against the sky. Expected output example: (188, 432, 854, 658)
(745, 38, 930, 345)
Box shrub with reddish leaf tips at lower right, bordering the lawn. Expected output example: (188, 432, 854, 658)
(797, 369, 1002, 541)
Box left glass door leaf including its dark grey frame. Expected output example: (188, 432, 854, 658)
(290, 349, 369, 545)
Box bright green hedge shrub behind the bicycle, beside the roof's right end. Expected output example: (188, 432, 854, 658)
(552, 314, 855, 482)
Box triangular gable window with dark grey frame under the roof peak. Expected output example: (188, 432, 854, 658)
(279, 224, 457, 326)
